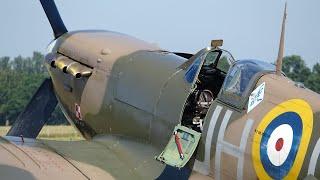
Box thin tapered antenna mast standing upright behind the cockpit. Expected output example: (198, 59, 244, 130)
(276, 2, 287, 75)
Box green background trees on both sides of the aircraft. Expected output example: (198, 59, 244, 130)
(0, 52, 320, 125)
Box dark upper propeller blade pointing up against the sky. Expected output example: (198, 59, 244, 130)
(40, 0, 68, 39)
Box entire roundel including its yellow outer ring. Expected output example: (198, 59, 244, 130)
(252, 99, 313, 179)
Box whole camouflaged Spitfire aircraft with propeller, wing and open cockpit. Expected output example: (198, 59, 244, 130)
(0, 0, 320, 180)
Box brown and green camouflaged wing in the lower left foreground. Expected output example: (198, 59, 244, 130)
(0, 136, 165, 180)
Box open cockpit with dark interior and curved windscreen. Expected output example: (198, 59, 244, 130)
(181, 48, 235, 132)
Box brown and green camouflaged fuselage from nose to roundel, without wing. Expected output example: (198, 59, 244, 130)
(46, 31, 320, 179)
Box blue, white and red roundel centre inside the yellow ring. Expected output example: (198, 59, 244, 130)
(260, 112, 302, 179)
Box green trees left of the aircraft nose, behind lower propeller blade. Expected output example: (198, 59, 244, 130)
(0, 52, 67, 125)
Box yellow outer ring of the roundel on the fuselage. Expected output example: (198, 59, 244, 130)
(252, 99, 313, 179)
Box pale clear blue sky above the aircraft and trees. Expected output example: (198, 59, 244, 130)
(0, 0, 320, 66)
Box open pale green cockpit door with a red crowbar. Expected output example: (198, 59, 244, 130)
(156, 125, 201, 169)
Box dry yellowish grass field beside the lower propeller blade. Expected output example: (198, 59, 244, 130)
(0, 125, 83, 141)
